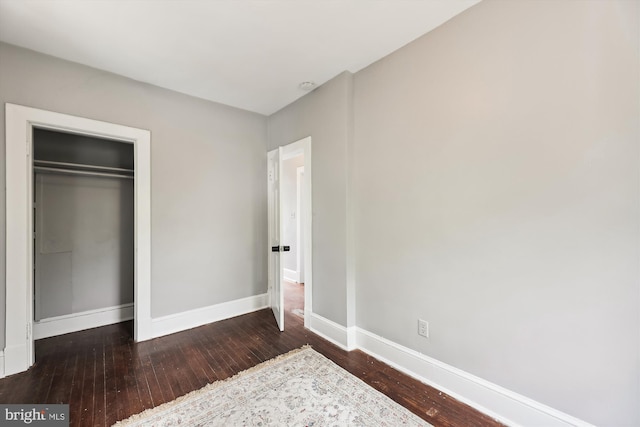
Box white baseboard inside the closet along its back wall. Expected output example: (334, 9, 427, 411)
(33, 303, 133, 340)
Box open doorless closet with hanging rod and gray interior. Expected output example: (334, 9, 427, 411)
(32, 127, 135, 340)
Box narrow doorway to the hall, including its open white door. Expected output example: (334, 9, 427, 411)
(267, 137, 313, 331)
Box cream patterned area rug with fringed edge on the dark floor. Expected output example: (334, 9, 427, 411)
(115, 346, 430, 427)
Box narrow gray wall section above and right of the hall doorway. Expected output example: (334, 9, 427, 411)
(268, 72, 352, 326)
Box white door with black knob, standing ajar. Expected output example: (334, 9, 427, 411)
(267, 147, 286, 331)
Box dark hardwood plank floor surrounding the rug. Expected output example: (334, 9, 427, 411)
(0, 283, 501, 426)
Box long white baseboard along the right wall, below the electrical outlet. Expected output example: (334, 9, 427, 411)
(356, 328, 593, 427)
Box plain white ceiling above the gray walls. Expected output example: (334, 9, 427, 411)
(0, 0, 479, 114)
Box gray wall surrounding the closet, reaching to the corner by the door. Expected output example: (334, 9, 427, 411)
(0, 44, 267, 338)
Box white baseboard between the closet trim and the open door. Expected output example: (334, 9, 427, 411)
(151, 294, 269, 338)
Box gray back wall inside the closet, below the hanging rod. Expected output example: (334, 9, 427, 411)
(35, 173, 134, 320)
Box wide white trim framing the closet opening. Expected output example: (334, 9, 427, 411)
(4, 103, 152, 375)
